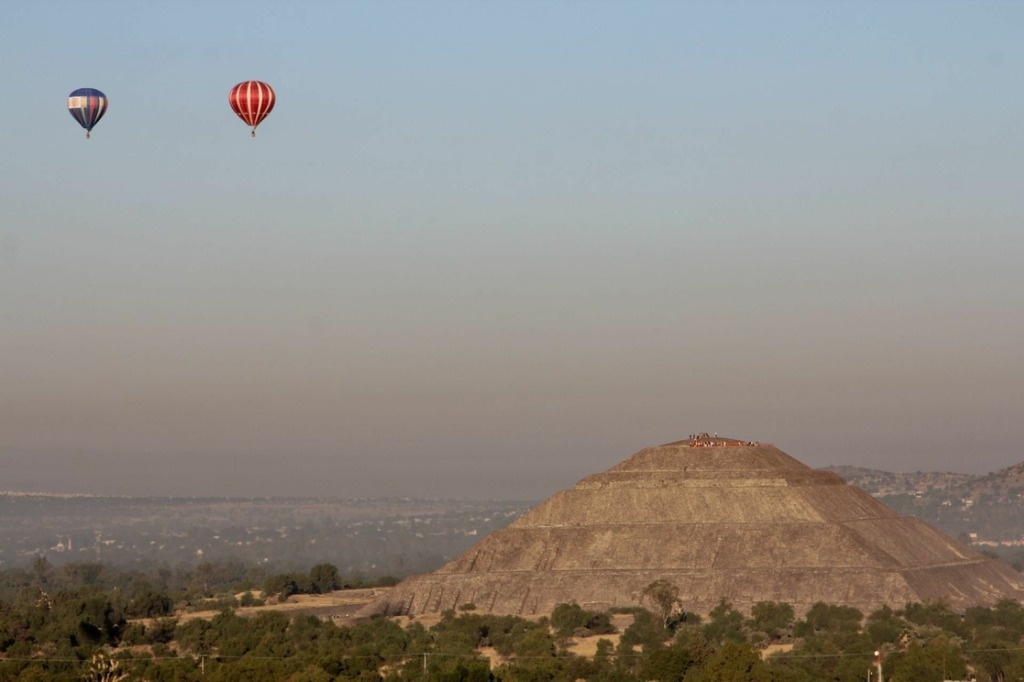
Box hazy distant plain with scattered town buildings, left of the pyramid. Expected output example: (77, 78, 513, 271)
(0, 492, 536, 578)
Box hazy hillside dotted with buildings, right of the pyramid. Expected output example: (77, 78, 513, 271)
(823, 462, 1024, 548)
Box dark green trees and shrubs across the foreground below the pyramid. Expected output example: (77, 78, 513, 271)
(0, 561, 1024, 682)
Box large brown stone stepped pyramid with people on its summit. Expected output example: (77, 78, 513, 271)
(362, 434, 1024, 615)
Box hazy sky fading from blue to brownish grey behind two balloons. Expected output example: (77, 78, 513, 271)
(0, 0, 1024, 499)
